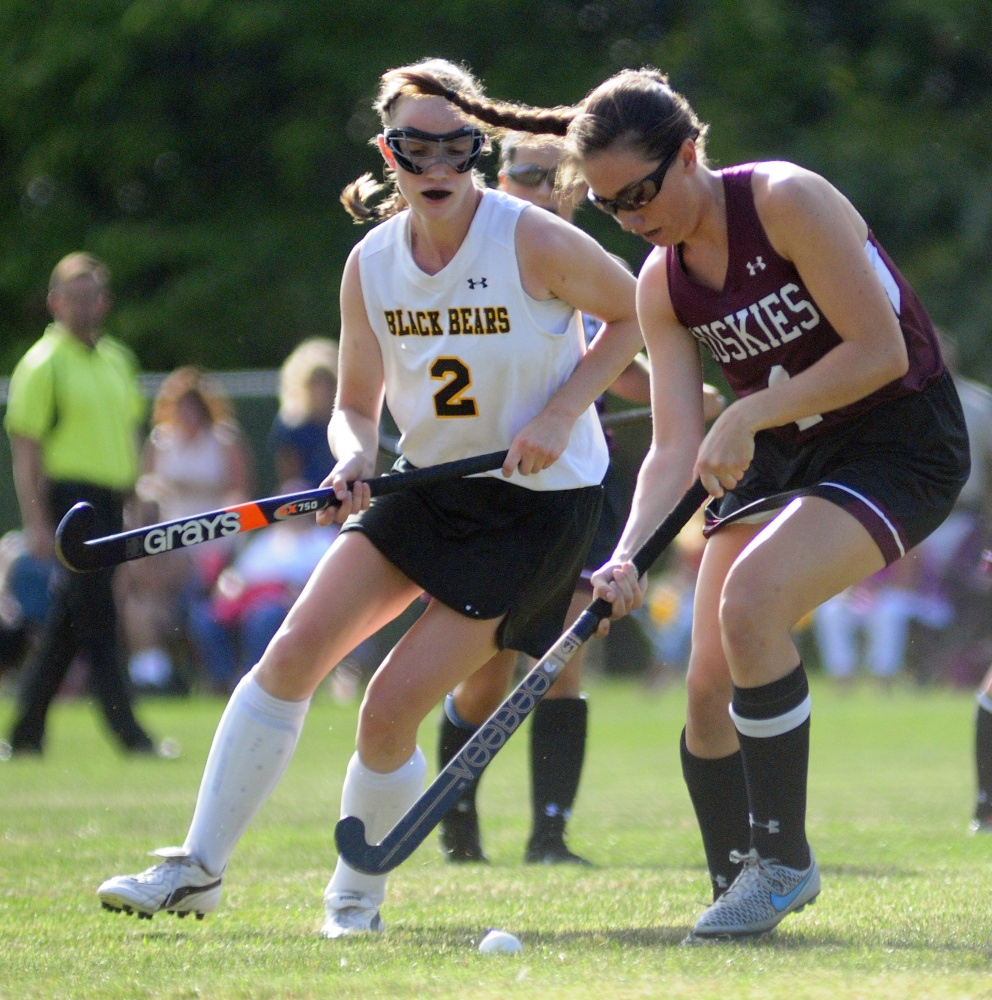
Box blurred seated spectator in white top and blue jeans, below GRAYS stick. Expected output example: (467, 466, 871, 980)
(190, 482, 337, 696)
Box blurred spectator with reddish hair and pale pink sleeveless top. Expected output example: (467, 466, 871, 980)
(120, 366, 250, 691)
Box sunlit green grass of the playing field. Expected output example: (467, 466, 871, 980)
(0, 681, 992, 1000)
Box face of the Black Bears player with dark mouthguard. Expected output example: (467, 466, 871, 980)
(379, 96, 475, 219)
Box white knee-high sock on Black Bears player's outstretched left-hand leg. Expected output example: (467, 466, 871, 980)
(184, 672, 310, 875)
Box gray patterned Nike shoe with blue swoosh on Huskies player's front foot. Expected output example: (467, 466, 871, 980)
(691, 850, 820, 938)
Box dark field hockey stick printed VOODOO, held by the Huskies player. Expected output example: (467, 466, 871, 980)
(334, 479, 706, 875)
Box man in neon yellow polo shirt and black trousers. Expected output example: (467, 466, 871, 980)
(4, 253, 154, 754)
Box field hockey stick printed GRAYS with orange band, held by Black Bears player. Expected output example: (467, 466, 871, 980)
(55, 451, 506, 573)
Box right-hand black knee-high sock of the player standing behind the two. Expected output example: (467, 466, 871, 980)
(530, 698, 589, 841)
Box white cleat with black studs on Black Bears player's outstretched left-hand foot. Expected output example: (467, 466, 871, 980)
(96, 847, 224, 920)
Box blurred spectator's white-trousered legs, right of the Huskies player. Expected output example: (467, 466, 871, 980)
(813, 546, 954, 685)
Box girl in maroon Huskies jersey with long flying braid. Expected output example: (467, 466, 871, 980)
(396, 69, 968, 938)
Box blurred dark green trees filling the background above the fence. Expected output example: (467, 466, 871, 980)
(0, 0, 992, 379)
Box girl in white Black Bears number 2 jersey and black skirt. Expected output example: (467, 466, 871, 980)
(98, 60, 641, 938)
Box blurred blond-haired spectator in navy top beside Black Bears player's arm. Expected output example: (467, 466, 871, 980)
(269, 337, 338, 489)
